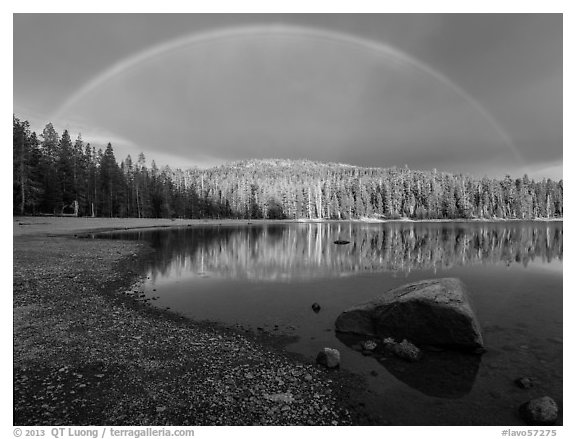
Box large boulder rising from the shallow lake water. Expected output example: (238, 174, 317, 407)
(336, 278, 483, 350)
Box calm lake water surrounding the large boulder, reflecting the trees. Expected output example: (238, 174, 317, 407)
(101, 222, 563, 425)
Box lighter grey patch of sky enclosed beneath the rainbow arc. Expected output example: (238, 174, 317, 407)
(49, 34, 512, 177)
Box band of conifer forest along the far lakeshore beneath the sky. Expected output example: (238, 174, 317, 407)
(13, 116, 563, 219)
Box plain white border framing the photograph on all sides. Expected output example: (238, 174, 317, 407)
(0, 0, 576, 439)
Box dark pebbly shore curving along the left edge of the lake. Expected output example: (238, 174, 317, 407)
(13, 218, 358, 425)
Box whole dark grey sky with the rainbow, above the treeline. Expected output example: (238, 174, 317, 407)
(14, 14, 562, 179)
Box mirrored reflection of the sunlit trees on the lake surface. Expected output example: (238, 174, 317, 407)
(100, 223, 563, 280)
